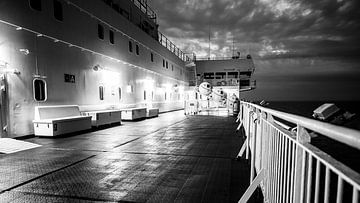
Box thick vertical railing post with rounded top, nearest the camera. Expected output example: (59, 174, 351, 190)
(293, 125, 310, 202)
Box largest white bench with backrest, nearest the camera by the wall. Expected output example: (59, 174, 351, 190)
(33, 105, 91, 136)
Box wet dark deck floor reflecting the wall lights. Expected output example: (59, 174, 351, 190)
(0, 111, 253, 202)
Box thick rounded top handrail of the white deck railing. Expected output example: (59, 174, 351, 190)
(242, 102, 360, 149)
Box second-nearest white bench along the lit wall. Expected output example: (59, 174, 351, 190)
(81, 110, 121, 127)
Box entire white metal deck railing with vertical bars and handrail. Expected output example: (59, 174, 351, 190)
(238, 102, 360, 203)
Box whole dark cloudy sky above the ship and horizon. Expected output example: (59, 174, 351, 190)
(148, 0, 360, 100)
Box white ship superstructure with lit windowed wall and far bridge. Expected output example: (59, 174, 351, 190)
(0, 0, 254, 138)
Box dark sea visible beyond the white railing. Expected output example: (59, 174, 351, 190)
(260, 101, 360, 173)
